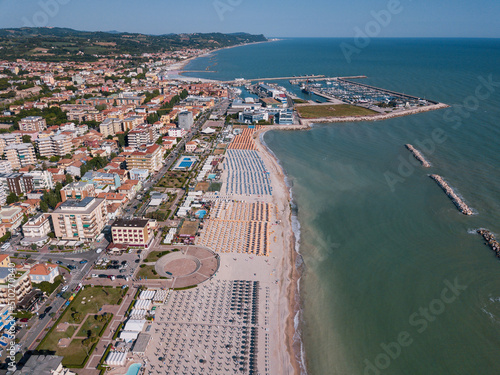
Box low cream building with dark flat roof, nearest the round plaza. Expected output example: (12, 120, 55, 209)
(111, 219, 154, 247)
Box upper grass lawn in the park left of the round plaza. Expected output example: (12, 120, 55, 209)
(61, 286, 123, 323)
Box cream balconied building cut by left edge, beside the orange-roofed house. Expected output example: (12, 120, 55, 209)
(0, 267, 33, 306)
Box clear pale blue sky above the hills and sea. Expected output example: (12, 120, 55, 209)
(0, 0, 500, 38)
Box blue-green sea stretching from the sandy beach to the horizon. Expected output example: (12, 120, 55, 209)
(186, 38, 500, 375)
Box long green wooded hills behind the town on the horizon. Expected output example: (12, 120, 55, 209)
(0, 27, 267, 61)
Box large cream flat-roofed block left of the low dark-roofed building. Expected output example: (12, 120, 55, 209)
(50, 197, 108, 241)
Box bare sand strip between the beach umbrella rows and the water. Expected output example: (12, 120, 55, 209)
(254, 125, 309, 375)
